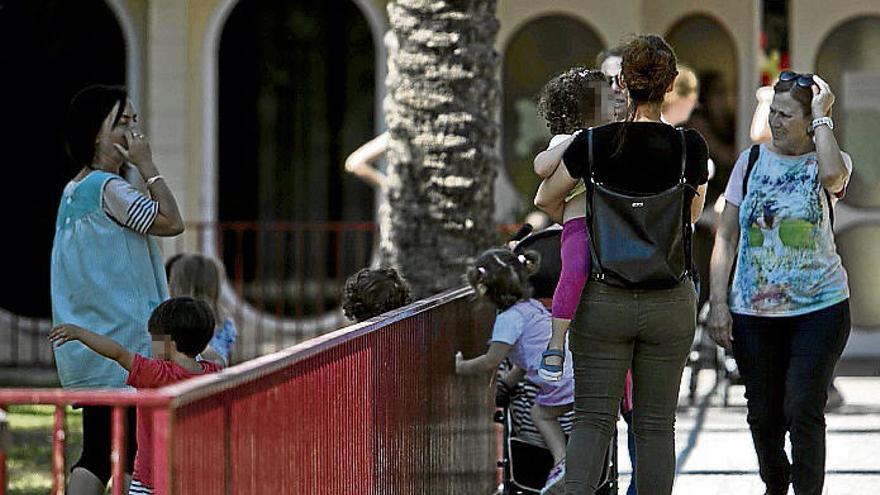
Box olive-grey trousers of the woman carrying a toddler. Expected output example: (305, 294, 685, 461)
(565, 280, 696, 495)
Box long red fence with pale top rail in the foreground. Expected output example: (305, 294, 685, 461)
(0, 289, 497, 495)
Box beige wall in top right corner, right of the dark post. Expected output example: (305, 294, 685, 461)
(789, 0, 880, 71)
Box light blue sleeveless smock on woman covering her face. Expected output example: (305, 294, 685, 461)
(51, 171, 168, 388)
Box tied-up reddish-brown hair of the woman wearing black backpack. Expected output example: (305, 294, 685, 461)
(621, 34, 678, 103)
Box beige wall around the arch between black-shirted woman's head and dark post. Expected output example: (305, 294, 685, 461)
(640, 0, 761, 149)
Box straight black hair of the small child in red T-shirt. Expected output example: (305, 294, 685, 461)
(148, 297, 214, 357)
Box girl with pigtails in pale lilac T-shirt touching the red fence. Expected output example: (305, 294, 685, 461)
(455, 248, 574, 490)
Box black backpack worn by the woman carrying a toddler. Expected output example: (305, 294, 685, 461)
(585, 128, 691, 289)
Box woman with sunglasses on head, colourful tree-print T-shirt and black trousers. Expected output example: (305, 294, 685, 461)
(707, 71, 852, 495)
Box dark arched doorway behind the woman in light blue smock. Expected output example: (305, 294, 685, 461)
(0, 0, 126, 317)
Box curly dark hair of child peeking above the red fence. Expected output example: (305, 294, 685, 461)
(342, 267, 412, 322)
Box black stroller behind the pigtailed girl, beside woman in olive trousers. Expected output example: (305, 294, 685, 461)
(495, 226, 617, 495)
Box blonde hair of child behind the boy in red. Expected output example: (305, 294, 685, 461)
(165, 253, 226, 326)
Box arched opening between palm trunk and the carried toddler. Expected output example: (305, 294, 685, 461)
(502, 15, 605, 211)
